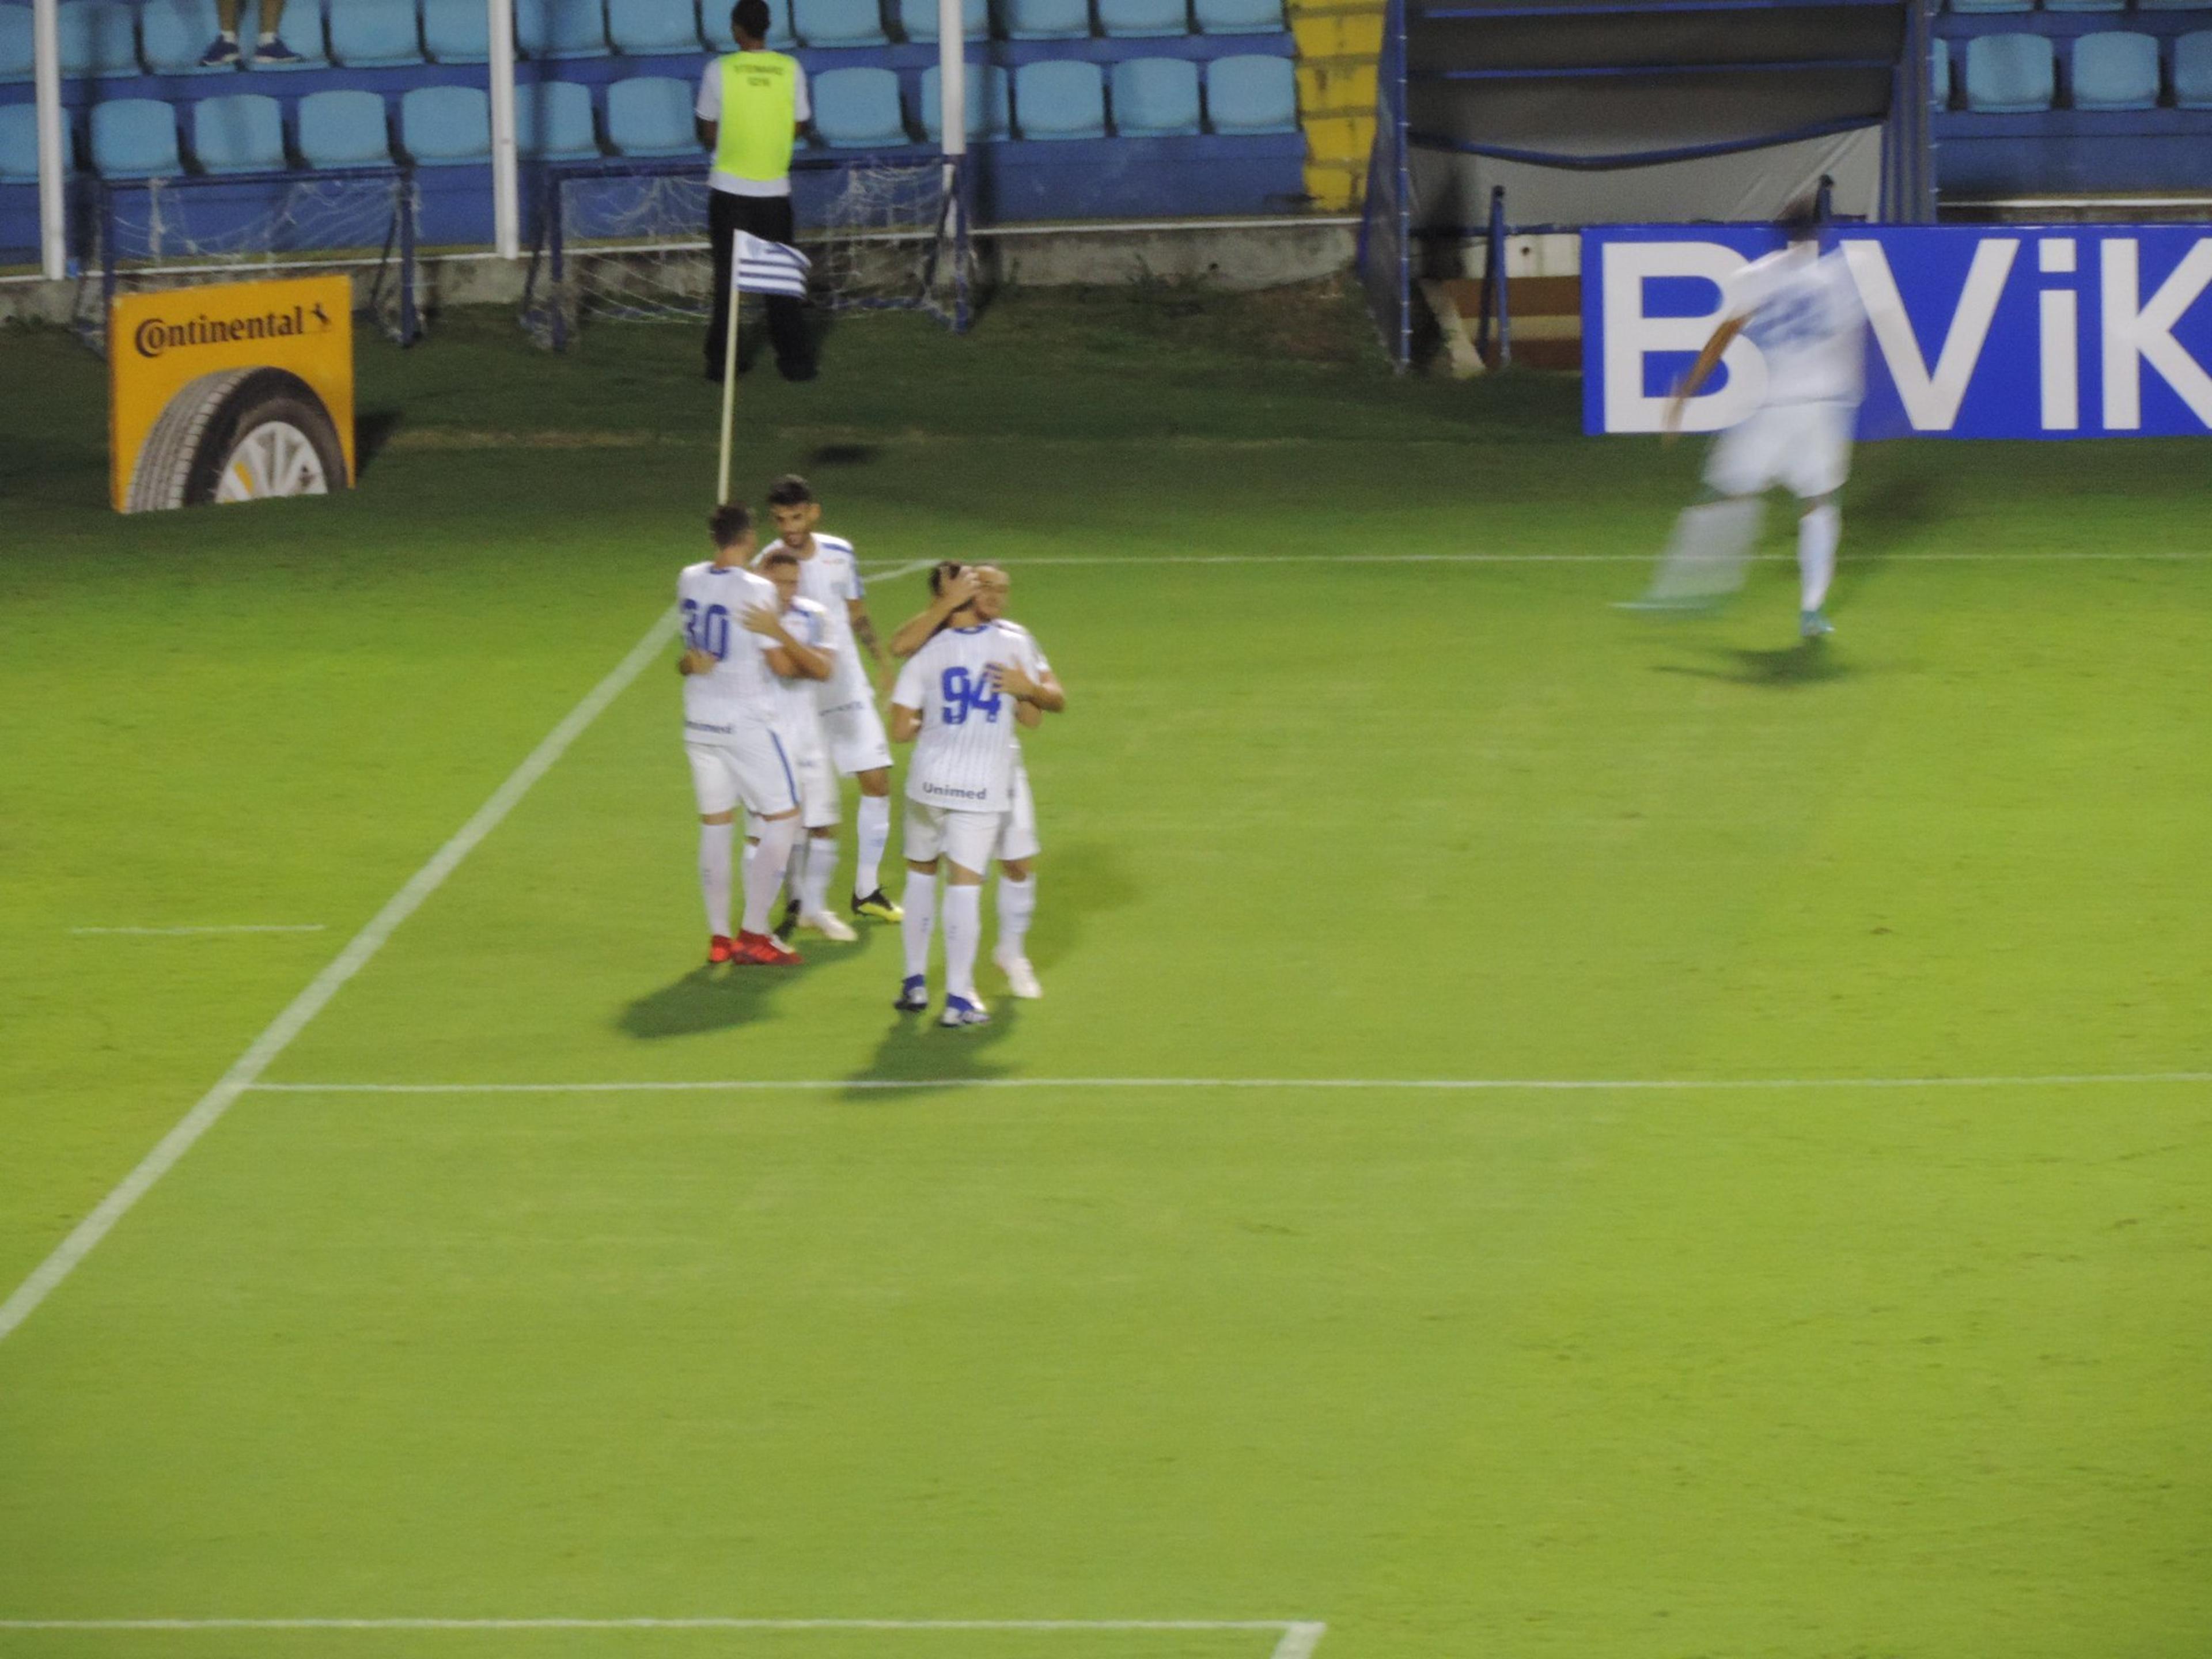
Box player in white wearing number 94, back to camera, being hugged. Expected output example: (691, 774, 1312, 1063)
(892, 564, 1066, 1027)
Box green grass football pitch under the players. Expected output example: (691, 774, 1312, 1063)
(0, 294, 2212, 1659)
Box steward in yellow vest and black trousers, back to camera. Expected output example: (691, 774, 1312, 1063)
(692, 0, 814, 380)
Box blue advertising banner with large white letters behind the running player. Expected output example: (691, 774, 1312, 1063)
(1582, 226, 2212, 438)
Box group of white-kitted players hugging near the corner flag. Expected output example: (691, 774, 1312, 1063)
(677, 476, 1066, 1027)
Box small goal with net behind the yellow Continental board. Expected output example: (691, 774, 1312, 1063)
(75, 168, 421, 352)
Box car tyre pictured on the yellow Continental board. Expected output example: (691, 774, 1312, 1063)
(126, 369, 347, 513)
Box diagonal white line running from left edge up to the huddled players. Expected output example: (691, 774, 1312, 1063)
(0, 611, 675, 1343)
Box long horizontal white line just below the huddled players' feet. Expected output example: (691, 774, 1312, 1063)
(248, 1071, 2212, 1095)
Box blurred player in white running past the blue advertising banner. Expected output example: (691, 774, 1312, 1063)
(1652, 197, 1867, 639)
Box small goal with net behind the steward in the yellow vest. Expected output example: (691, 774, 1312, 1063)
(522, 155, 975, 352)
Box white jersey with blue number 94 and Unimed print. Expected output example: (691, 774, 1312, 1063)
(892, 619, 1051, 812)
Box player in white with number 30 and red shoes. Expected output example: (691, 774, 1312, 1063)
(677, 502, 830, 967)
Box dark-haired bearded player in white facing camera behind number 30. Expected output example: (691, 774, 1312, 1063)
(761, 474, 898, 922)
